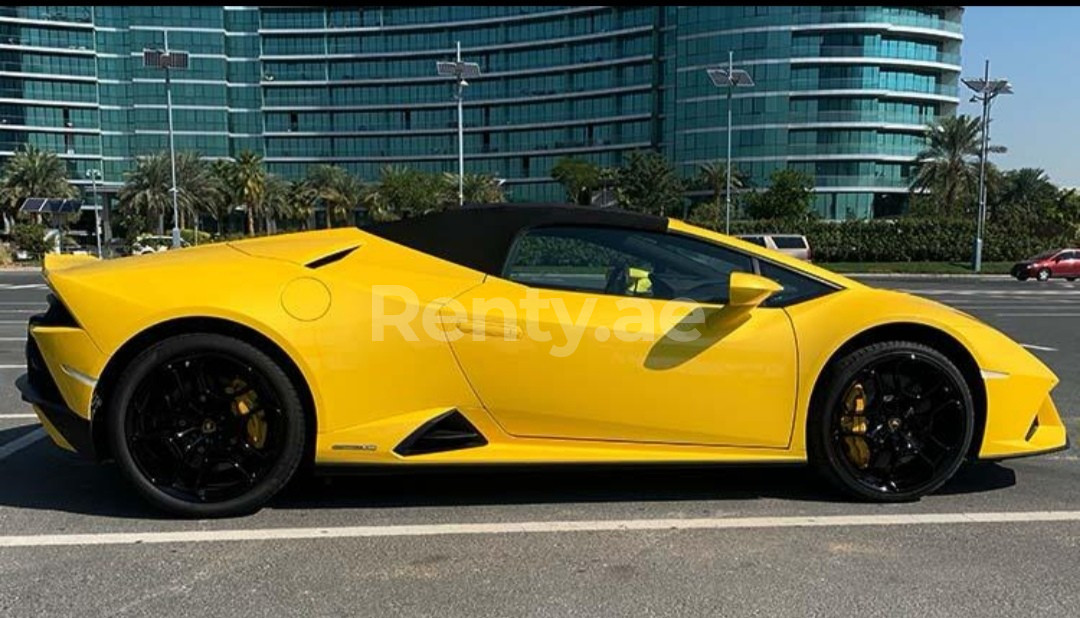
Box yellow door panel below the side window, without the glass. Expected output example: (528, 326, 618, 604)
(451, 277, 796, 448)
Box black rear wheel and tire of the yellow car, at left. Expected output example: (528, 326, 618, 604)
(107, 333, 306, 518)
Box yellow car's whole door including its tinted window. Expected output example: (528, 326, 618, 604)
(443, 226, 797, 447)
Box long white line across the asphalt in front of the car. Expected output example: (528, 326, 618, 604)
(0, 511, 1080, 548)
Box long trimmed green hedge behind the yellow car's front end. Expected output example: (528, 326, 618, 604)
(696, 218, 1078, 261)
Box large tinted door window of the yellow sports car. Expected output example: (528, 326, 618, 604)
(503, 226, 753, 304)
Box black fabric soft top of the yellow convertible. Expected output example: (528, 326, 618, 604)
(362, 203, 667, 274)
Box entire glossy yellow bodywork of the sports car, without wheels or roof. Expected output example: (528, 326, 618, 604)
(31, 220, 1066, 465)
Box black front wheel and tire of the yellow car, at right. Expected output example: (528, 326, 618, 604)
(807, 341, 975, 502)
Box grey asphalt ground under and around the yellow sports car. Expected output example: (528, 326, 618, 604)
(0, 273, 1080, 617)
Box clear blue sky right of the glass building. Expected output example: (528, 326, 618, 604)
(959, 6, 1080, 188)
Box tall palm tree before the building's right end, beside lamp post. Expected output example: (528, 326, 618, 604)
(912, 116, 983, 214)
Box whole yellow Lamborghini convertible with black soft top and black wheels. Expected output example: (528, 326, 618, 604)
(18, 204, 1067, 516)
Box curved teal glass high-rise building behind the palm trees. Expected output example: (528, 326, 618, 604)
(0, 5, 962, 218)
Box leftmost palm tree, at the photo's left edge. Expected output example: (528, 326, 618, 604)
(0, 145, 76, 229)
